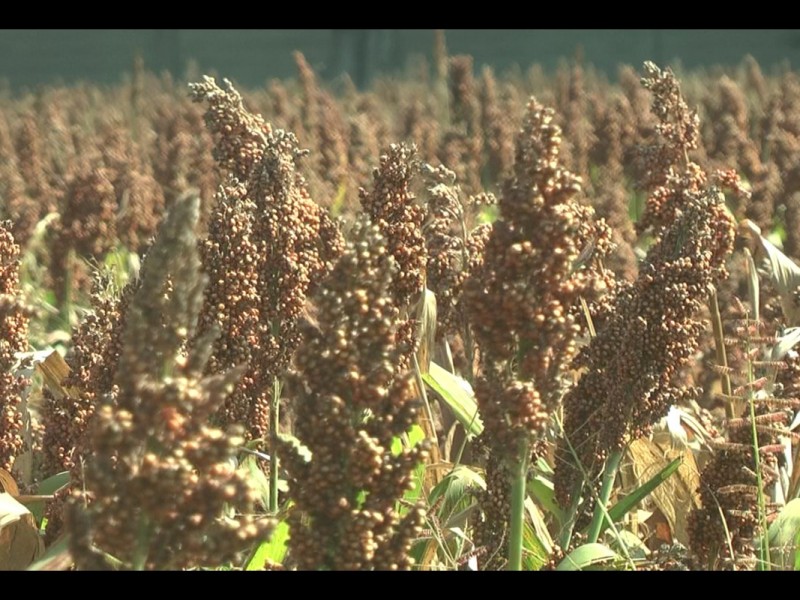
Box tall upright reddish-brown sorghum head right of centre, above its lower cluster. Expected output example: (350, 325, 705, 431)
(465, 100, 609, 402)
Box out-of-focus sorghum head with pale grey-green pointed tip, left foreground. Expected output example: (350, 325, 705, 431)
(66, 198, 271, 569)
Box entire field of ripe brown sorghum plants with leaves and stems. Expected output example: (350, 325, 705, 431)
(0, 43, 800, 571)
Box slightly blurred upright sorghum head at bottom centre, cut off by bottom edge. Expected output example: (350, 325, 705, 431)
(282, 219, 426, 570)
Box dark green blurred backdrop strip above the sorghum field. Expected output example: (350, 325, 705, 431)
(0, 29, 800, 89)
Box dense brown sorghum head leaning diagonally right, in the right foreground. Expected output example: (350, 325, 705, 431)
(556, 190, 734, 504)
